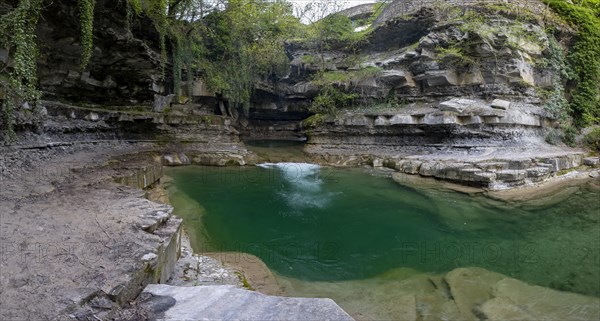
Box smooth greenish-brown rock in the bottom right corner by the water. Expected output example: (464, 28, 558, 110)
(276, 267, 600, 321)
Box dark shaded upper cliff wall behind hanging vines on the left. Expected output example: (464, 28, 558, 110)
(38, 0, 168, 105)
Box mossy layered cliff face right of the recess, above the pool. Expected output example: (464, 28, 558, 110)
(251, 0, 564, 147)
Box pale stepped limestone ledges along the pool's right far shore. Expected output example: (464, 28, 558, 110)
(305, 99, 598, 189)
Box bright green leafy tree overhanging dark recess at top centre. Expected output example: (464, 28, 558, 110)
(198, 0, 300, 112)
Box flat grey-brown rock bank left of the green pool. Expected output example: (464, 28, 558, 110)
(0, 143, 182, 320)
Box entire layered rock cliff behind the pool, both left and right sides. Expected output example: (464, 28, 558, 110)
(1, 0, 580, 178)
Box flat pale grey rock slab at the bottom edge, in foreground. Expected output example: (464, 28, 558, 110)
(144, 284, 354, 321)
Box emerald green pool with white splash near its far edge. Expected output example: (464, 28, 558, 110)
(167, 163, 600, 300)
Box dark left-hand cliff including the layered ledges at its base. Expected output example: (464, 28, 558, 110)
(0, 0, 245, 151)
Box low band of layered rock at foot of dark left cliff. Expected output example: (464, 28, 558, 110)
(42, 101, 241, 147)
